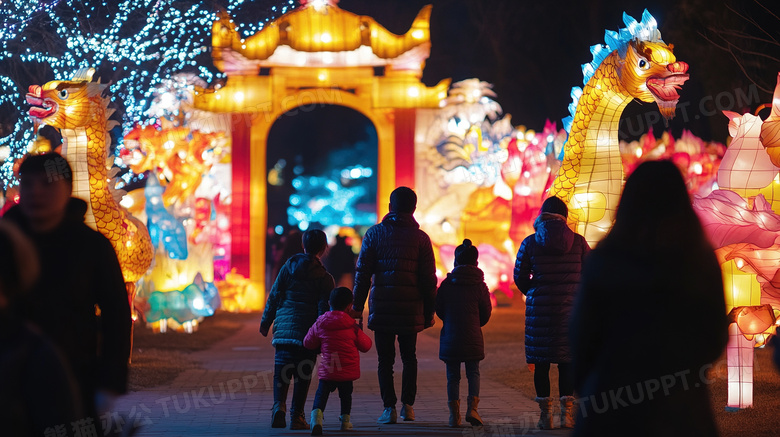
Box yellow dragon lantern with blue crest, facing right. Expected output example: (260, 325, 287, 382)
(549, 10, 688, 246)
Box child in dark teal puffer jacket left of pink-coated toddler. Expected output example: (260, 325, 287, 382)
(260, 229, 334, 429)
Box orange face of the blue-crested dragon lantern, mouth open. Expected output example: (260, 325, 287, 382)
(618, 39, 688, 119)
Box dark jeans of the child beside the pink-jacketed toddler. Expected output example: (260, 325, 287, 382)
(274, 345, 317, 417)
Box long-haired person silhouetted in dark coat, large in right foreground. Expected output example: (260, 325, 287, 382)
(570, 161, 728, 437)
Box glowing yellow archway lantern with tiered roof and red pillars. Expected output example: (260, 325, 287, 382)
(194, 0, 450, 292)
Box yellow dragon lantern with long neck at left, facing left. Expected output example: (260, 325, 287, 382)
(27, 69, 154, 297)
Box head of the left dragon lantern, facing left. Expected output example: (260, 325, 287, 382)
(26, 69, 107, 129)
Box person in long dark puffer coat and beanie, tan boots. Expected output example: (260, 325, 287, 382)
(514, 197, 590, 429)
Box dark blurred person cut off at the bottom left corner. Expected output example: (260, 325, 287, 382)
(0, 220, 83, 437)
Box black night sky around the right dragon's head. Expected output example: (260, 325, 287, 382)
(338, 0, 780, 142)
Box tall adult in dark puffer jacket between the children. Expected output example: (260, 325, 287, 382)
(353, 187, 436, 423)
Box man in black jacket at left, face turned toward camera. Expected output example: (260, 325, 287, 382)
(3, 153, 132, 435)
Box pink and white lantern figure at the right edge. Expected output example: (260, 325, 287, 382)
(694, 76, 780, 411)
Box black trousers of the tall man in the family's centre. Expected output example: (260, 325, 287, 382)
(374, 332, 417, 408)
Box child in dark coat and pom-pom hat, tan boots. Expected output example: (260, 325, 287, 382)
(436, 239, 492, 427)
